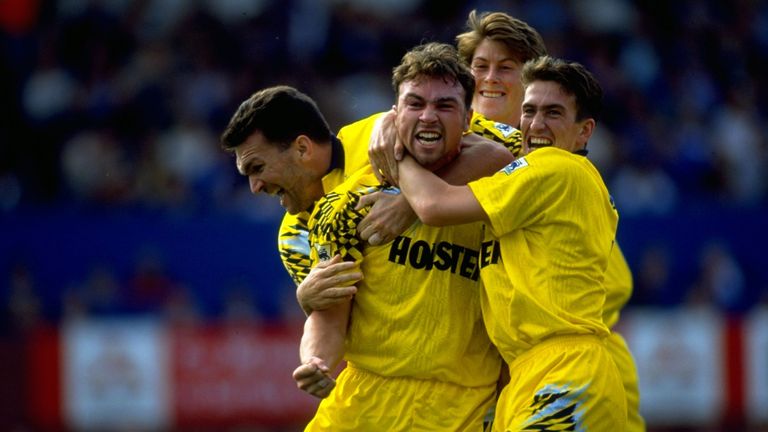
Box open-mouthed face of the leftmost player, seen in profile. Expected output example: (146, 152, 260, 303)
(235, 131, 323, 214)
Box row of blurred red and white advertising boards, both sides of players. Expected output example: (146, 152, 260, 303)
(25, 308, 768, 430)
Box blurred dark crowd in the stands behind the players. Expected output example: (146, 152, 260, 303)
(0, 0, 768, 327)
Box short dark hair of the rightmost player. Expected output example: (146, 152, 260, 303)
(521, 56, 603, 121)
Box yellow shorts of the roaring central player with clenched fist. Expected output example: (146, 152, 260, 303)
(304, 366, 496, 432)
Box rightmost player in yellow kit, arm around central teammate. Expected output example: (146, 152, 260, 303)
(399, 56, 626, 431)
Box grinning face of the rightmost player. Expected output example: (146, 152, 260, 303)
(520, 81, 595, 153)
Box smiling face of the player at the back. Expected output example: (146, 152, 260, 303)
(471, 38, 523, 127)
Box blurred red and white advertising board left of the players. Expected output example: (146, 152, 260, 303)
(45, 318, 318, 430)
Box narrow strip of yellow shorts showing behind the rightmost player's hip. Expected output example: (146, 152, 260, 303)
(605, 332, 645, 432)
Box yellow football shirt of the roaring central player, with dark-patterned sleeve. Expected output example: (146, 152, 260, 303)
(309, 166, 501, 391)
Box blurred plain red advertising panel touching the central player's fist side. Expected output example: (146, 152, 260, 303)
(172, 325, 318, 428)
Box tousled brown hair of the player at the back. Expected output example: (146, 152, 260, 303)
(456, 10, 547, 64)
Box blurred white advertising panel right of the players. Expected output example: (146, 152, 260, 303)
(620, 309, 725, 426)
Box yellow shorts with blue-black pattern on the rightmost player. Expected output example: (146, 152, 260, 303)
(493, 336, 627, 432)
